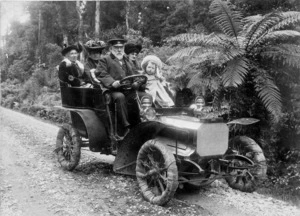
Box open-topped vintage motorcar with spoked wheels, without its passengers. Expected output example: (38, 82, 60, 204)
(55, 75, 266, 205)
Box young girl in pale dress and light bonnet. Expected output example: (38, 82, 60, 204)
(141, 55, 174, 107)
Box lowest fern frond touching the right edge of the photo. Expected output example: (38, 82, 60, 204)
(260, 44, 300, 68)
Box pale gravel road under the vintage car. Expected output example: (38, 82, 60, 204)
(0, 107, 300, 216)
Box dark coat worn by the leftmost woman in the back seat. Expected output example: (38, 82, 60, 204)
(58, 60, 85, 87)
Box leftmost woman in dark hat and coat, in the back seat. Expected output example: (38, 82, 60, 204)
(58, 45, 91, 88)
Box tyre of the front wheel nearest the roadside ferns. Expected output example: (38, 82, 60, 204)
(225, 136, 267, 192)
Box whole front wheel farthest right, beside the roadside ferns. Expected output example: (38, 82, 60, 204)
(225, 136, 267, 192)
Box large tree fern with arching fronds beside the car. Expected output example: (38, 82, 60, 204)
(168, 0, 300, 119)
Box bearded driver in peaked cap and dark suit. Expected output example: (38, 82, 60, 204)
(92, 38, 152, 134)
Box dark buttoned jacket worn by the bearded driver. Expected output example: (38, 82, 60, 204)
(95, 54, 135, 88)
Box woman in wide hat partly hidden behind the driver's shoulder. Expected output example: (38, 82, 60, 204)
(84, 40, 106, 84)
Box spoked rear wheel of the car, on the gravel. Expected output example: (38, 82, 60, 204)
(56, 124, 81, 171)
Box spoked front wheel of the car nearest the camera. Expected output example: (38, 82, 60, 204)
(136, 140, 178, 205)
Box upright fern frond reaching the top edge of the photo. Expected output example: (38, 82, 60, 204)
(209, 0, 242, 38)
